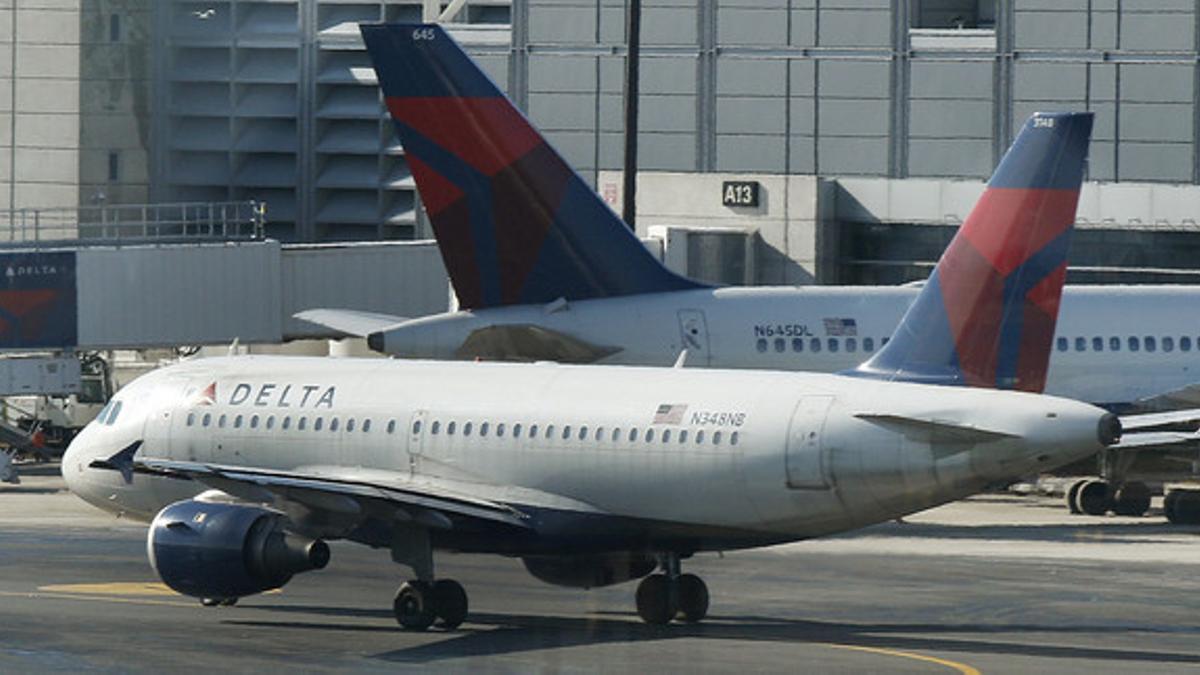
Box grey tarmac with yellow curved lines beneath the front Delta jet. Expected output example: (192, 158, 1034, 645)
(0, 470, 1200, 674)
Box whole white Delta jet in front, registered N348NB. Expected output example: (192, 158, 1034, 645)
(62, 25, 1152, 629)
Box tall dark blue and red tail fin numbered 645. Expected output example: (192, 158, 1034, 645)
(360, 24, 703, 309)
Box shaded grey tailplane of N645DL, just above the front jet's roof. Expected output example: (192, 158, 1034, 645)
(455, 323, 620, 364)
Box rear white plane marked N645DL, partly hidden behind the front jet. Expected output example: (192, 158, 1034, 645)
(288, 22, 1200, 522)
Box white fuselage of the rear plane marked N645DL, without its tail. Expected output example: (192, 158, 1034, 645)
(376, 286, 1200, 408)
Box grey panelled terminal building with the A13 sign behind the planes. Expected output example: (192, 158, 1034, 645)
(0, 0, 1200, 283)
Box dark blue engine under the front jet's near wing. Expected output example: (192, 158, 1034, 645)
(146, 500, 329, 598)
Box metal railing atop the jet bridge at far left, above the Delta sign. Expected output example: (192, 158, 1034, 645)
(0, 202, 266, 246)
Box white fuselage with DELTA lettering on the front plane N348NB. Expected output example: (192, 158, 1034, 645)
(62, 357, 1105, 555)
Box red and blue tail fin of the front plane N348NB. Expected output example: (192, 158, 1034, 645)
(852, 113, 1092, 392)
